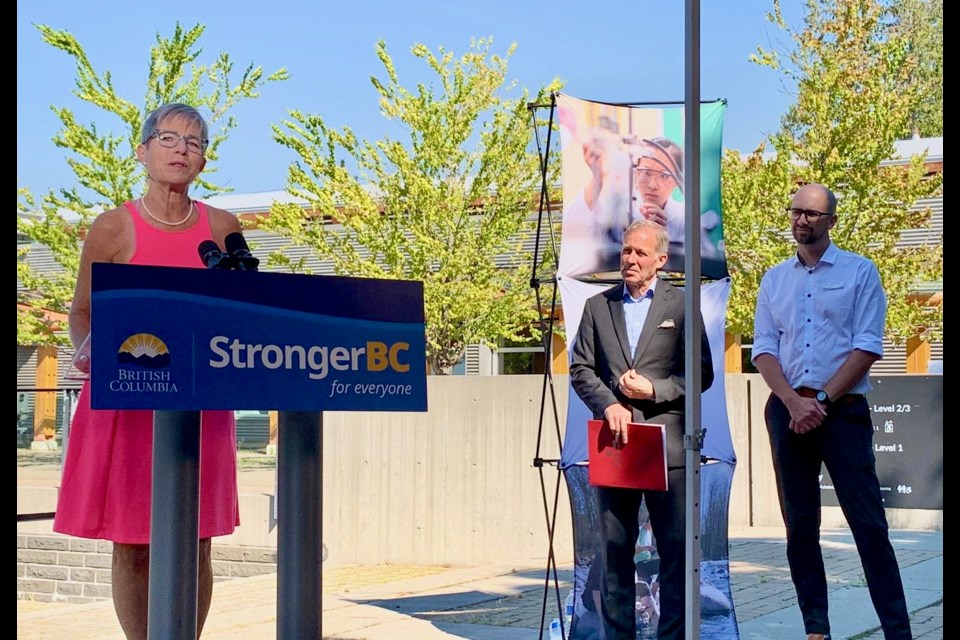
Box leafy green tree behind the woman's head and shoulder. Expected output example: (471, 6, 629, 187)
(17, 23, 287, 344)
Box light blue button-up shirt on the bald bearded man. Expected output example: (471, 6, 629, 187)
(752, 242, 887, 393)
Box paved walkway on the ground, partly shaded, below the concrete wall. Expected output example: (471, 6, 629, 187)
(17, 529, 944, 640)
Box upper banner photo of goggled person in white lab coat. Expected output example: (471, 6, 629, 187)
(557, 94, 728, 279)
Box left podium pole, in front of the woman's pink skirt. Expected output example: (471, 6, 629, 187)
(147, 411, 200, 640)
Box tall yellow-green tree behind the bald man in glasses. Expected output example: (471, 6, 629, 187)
(723, 0, 943, 342)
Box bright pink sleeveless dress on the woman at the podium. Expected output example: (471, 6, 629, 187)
(53, 202, 240, 544)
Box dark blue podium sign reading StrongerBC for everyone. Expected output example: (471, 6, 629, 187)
(90, 263, 427, 411)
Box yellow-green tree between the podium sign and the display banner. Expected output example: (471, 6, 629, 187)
(260, 39, 558, 373)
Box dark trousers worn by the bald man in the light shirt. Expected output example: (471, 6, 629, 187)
(764, 394, 913, 640)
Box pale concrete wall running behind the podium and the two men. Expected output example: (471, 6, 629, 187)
(17, 374, 943, 600)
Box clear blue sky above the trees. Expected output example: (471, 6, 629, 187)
(17, 0, 803, 195)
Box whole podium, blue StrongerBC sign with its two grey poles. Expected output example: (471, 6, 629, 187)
(90, 263, 427, 640)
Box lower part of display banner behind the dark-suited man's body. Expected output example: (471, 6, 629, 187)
(558, 277, 740, 640)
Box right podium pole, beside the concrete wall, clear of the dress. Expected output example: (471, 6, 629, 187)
(277, 411, 323, 640)
